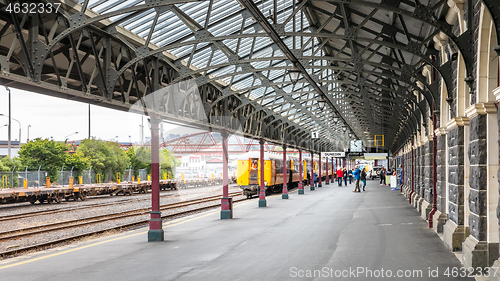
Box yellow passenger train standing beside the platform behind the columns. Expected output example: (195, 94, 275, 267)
(236, 151, 331, 198)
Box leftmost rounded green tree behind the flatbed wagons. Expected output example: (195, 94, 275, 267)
(19, 138, 67, 182)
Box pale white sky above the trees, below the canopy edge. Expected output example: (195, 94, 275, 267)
(0, 86, 179, 143)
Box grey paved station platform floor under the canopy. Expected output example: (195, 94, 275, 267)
(0, 180, 474, 281)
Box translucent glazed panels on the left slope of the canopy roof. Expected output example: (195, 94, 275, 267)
(79, 0, 350, 149)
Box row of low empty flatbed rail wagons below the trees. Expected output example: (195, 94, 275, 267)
(0, 180, 177, 204)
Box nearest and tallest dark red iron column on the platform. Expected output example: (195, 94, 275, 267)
(148, 117, 164, 242)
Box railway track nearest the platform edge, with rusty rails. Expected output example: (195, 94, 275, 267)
(0, 192, 247, 257)
